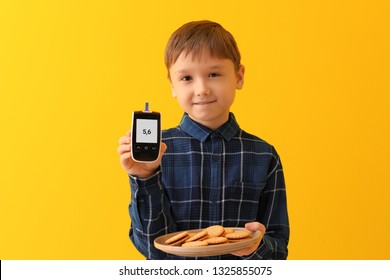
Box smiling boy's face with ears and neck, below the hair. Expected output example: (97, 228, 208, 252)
(169, 52, 244, 129)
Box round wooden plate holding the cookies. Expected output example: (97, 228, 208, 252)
(154, 228, 263, 257)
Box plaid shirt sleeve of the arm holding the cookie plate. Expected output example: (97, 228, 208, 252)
(243, 147, 290, 260)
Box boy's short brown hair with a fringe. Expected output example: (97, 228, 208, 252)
(165, 20, 241, 76)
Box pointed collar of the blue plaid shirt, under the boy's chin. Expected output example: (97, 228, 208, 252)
(180, 113, 240, 142)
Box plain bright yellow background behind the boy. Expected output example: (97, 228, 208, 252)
(0, 0, 390, 259)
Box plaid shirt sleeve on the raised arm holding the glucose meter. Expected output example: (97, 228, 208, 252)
(129, 170, 176, 259)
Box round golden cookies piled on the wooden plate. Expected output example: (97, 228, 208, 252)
(165, 225, 251, 247)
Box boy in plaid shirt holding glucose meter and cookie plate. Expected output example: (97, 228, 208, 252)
(118, 21, 289, 259)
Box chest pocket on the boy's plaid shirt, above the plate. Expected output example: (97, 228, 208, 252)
(223, 182, 266, 226)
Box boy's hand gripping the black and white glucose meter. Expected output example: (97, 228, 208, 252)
(118, 131, 167, 179)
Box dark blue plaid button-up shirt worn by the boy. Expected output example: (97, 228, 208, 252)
(129, 113, 289, 259)
